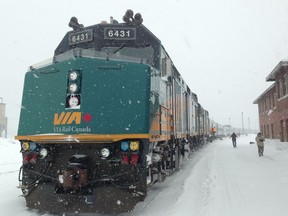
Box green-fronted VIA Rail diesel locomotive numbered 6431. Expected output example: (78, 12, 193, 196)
(16, 10, 210, 213)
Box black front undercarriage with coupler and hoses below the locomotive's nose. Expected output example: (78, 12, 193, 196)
(19, 144, 147, 213)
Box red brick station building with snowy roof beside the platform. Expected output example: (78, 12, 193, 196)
(253, 59, 288, 141)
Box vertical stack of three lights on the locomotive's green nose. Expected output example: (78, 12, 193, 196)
(66, 70, 82, 109)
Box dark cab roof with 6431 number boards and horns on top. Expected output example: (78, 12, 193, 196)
(54, 12, 161, 56)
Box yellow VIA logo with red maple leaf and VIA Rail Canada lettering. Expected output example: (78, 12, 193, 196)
(53, 112, 93, 133)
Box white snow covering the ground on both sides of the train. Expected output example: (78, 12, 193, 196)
(0, 135, 288, 216)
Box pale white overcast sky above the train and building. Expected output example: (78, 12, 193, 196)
(0, 0, 288, 137)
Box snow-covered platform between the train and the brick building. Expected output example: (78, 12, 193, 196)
(168, 136, 288, 216)
